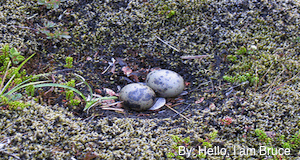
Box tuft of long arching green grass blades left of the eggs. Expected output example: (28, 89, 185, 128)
(0, 45, 117, 111)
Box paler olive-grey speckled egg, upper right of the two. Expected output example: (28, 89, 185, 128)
(146, 69, 184, 97)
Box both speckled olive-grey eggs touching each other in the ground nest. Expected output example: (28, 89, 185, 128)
(119, 69, 184, 111)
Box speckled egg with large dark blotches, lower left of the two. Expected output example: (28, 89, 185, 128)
(119, 83, 155, 111)
